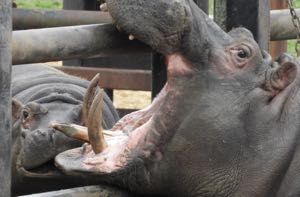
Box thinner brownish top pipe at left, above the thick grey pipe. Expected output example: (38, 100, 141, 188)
(12, 8, 112, 30)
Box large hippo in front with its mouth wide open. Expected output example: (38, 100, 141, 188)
(55, 0, 300, 197)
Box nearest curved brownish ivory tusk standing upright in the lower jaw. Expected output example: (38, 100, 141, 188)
(87, 90, 107, 154)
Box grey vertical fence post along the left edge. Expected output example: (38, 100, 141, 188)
(0, 0, 12, 197)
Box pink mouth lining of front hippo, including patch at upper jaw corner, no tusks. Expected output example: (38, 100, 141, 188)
(55, 54, 192, 174)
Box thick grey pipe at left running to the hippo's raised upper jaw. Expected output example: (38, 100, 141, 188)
(12, 24, 140, 64)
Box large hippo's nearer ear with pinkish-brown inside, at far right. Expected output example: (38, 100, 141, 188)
(265, 61, 297, 94)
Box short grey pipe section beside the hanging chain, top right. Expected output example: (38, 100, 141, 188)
(271, 9, 300, 41)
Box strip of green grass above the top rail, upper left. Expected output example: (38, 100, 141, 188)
(15, 0, 62, 9)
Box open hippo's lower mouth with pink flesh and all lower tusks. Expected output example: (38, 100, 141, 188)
(52, 58, 185, 175)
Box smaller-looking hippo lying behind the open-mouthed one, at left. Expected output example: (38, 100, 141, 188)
(12, 64, 118, 194)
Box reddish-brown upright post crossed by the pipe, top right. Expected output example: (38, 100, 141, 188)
(269, 0, 288, 58)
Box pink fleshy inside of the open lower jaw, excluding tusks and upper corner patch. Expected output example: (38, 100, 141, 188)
(56, 81, 167, 173)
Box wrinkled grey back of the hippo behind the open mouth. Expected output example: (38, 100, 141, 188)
(12, 64, 119, 128)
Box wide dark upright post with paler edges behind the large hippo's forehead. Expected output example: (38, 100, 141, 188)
(214, 0, 270, 50)
